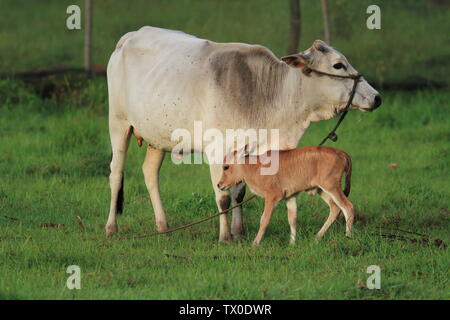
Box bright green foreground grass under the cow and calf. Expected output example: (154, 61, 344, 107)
(0, 79, 450, 299)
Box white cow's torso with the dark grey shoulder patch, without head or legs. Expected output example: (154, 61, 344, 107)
(108, 27, 294, 150)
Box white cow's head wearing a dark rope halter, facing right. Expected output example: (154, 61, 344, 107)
(282, 40, 381, 116)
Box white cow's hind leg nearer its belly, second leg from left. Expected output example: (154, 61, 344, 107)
(142, 146, 168, 232)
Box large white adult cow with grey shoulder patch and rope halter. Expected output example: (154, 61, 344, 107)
(106, 27, 381, 241)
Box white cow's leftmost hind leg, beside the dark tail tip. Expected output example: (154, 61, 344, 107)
(105, 120, 131, 236)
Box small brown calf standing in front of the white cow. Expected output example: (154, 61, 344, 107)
(217, 146, 354, 245)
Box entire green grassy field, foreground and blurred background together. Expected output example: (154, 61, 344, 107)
(0, 0, 450, 299)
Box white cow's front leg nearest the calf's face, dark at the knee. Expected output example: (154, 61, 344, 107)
(209, 164, 231, 242)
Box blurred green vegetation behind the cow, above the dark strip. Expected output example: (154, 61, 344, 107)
(0, 0, 450, 87)
